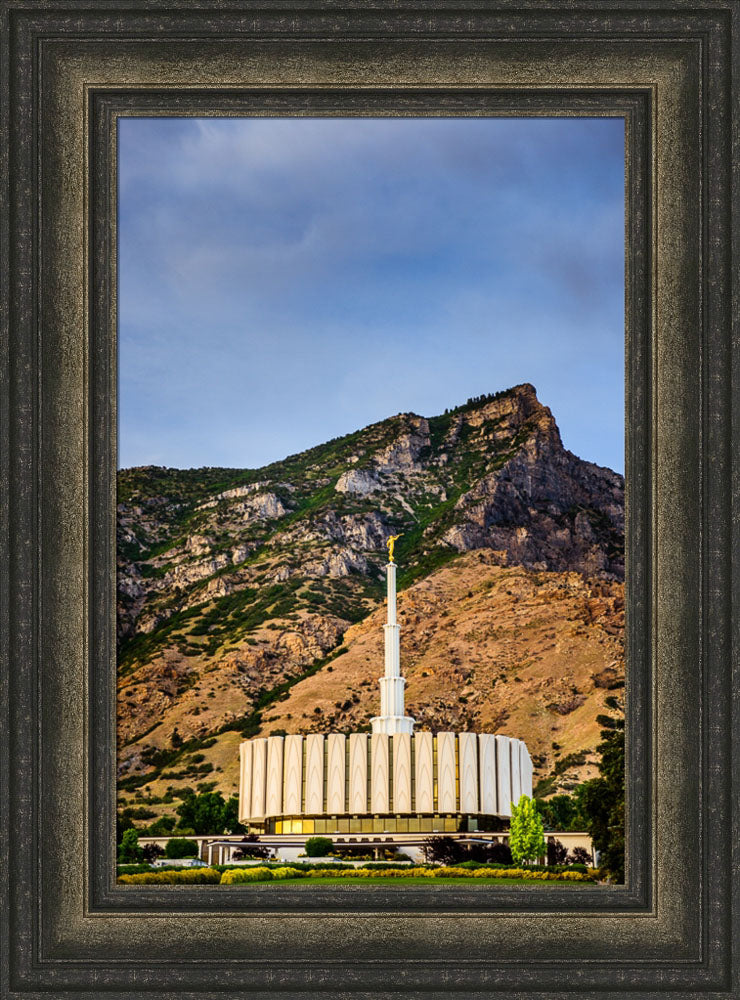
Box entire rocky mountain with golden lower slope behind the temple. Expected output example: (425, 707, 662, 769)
(118, 384, 624, 811)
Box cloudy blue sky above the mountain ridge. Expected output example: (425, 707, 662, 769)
(118, 118, 624, 472)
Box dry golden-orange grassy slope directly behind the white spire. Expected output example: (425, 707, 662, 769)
(121, 549, 624, 812)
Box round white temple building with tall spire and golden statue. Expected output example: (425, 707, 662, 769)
(239, 547, 532, 836)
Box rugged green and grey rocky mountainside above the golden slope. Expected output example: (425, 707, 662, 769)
(118, 384, 624, 804)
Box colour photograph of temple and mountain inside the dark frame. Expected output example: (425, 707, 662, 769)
(116, 115, 625, 888)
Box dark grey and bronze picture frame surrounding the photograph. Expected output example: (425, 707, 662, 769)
(0, 0, 740, 1000)
